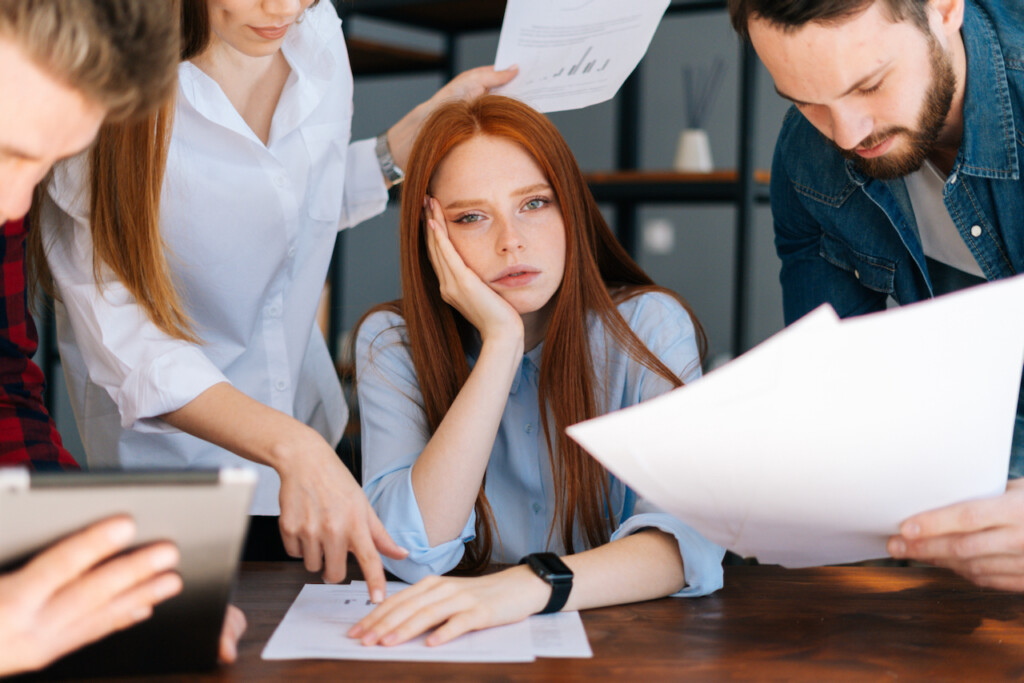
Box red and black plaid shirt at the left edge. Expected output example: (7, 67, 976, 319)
(0, 220, 78, 470)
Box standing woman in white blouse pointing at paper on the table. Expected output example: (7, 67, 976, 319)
(37, 0, 514, 600)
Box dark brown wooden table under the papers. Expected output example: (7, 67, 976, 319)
(130, 563, 1024, 683)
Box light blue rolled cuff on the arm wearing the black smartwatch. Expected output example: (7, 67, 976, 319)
(611, 512, 725, 598)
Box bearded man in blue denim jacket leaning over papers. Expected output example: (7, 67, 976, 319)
(729, 0, 1024, 591)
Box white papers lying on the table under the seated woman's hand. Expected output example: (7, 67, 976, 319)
(263, 582, 593, 661)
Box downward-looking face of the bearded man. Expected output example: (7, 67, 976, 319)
(750, 2, 956, 179)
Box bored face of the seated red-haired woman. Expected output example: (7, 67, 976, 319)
(429, 135, 565, 323)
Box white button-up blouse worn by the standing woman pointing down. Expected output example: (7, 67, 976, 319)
(42, 2, 387, 514)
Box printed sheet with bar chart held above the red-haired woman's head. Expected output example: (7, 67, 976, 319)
(495, 0, 670, 112)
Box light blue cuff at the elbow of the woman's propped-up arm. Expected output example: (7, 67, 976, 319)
(367, 468, 476, 584)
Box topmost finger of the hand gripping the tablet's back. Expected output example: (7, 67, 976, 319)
(25, 516, 135, 595)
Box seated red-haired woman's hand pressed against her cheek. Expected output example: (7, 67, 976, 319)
(424, 197, 523, 343)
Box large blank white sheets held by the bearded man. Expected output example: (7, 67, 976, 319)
(568, 275, 1024, 566)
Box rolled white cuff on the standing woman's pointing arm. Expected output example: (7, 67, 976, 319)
(115, 346, 228, 433)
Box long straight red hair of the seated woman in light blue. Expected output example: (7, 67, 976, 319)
(364, 95, 706, 570)
